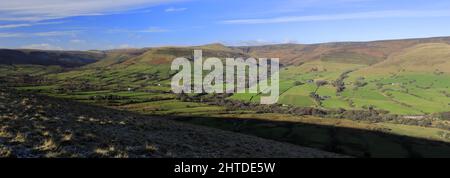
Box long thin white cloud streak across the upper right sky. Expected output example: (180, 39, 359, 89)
(220, 10, 450, 24)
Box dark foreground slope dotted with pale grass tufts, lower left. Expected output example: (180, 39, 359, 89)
(0, 89, 342, 158)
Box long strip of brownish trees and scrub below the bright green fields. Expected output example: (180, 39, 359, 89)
(177, 94, 450, 130)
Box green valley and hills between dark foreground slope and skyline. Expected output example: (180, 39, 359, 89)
(0, 38, 450, 157)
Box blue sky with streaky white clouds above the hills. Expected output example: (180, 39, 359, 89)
(0, 0, 450, 50)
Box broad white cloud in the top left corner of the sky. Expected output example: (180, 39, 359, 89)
(0, 0, 182, 21)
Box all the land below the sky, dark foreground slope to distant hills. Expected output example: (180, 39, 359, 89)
(0, 37, 450, 157)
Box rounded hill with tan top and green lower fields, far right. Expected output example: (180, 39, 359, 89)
(347, 43, 450, 114)
